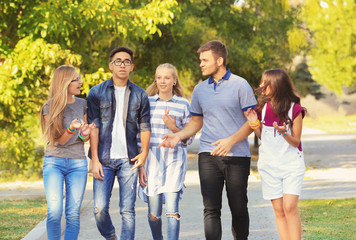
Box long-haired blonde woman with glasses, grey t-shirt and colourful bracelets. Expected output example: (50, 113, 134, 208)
(41, 66, 95, 240)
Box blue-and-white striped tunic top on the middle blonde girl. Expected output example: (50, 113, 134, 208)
(138, 94, 194, 202)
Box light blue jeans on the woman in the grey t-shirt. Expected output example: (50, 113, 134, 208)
(43, 157, 88, 240)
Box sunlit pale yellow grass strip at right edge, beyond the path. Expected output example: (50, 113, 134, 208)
(303, 114, 356, 133)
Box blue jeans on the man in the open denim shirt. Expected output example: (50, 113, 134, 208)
(93, 159, 138, 240)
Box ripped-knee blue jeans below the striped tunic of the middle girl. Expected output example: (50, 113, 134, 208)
(148, 192, 180, 240)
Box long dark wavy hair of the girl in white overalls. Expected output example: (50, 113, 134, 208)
(256, 69, 306, 127)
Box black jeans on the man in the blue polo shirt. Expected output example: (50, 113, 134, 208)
(199, 152, 251, 240)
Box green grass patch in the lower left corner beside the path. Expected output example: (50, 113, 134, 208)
(0, 199, 47, 240)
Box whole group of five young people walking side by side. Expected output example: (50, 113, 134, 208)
(41, 40, 306, 240)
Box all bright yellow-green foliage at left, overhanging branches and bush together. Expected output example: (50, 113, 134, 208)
(0, 0, 177, 177)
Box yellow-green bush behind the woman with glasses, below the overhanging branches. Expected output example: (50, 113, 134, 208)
(0, 37, 81, 177)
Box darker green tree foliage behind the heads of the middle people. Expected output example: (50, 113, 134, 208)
(135, 0, 307, 91)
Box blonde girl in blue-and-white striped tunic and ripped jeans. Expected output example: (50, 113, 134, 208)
(139, 63, 193, 240)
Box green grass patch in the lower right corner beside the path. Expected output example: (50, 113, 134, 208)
(298, 198, 356, 240)
